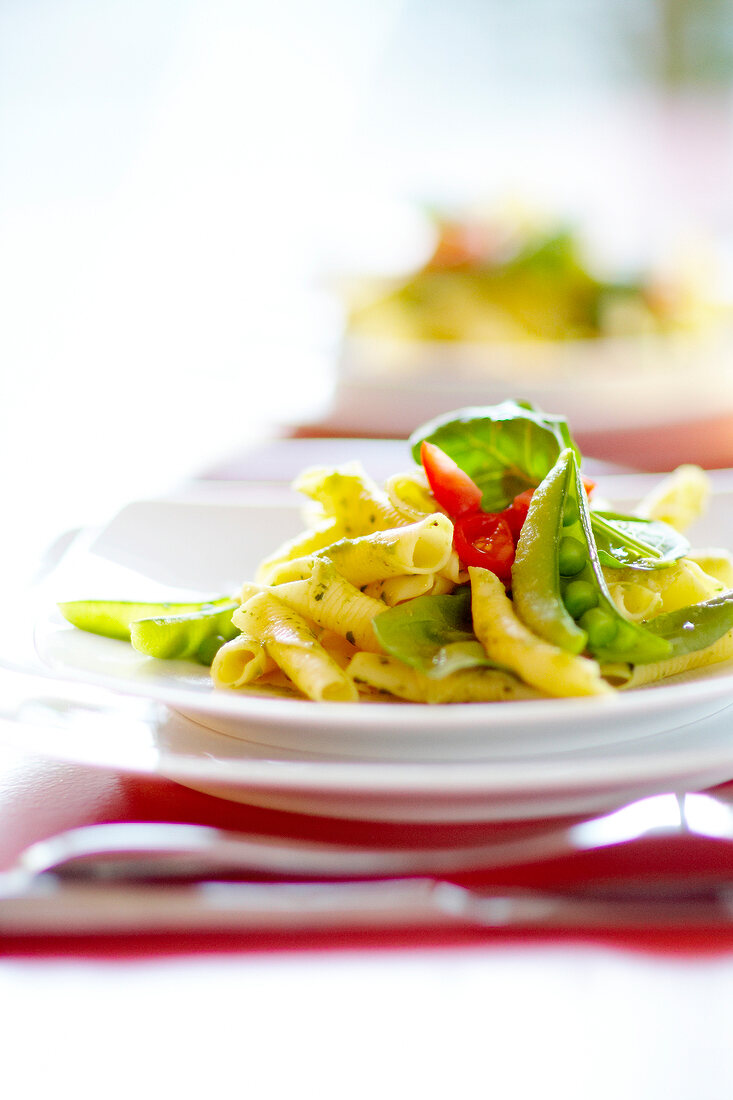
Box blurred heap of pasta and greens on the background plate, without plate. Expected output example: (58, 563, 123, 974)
(344, 204, 713, 343)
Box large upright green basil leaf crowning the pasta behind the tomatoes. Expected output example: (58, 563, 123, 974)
(409, 402, 580, 512)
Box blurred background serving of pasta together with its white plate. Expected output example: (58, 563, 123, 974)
(303, 202, 733, 470)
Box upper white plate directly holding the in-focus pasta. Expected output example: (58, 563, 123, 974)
(25, 468, 733, 762)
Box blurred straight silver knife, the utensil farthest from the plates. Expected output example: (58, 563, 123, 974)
(0, 872, 733, 936)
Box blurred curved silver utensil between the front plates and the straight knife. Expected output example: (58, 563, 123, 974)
(8, 793, 733, 882)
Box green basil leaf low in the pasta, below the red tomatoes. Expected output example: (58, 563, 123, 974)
(373, 587, 496, 680)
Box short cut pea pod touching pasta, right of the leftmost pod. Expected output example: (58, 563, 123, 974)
(130, 600, 239, 664)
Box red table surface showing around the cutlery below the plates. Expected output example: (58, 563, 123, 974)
(0, 751, 733, 957)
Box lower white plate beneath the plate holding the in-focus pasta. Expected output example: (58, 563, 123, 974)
(0, 673, 733, 822)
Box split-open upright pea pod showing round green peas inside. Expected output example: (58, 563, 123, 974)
(512, 448, 672, 664)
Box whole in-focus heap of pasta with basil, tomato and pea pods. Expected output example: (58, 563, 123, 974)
(59, 402, 733, 705)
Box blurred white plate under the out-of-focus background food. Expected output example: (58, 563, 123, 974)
(327, 327, 733, 436)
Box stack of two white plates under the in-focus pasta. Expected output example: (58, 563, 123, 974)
(0, 471, 733, 821)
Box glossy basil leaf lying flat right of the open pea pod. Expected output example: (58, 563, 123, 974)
(591, 512, 690, 569)
